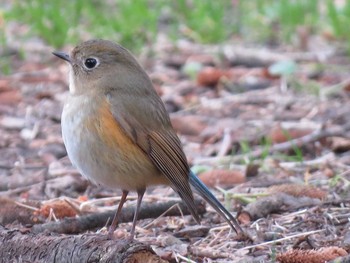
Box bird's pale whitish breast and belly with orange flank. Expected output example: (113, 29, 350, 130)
(62, 95, 166, 190)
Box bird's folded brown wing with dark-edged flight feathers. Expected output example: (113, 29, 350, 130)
(106, 90, 200, 223)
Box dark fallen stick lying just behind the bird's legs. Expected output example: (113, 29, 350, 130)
(32, 200, 206, 234)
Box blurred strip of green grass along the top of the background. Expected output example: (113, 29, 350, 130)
(5, 0, 350, 54)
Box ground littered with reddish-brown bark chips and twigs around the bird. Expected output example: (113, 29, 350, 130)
(0, 30, 350, 262)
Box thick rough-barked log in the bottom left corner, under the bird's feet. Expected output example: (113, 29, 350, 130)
(0, 226, 168, 263)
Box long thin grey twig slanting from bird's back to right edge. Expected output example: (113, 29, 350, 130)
(196, 123, 350, 165)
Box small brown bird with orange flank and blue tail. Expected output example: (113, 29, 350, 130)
(53, 39, 243, 240)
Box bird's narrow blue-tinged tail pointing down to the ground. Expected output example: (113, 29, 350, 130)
(189, 171, 243, 233)
